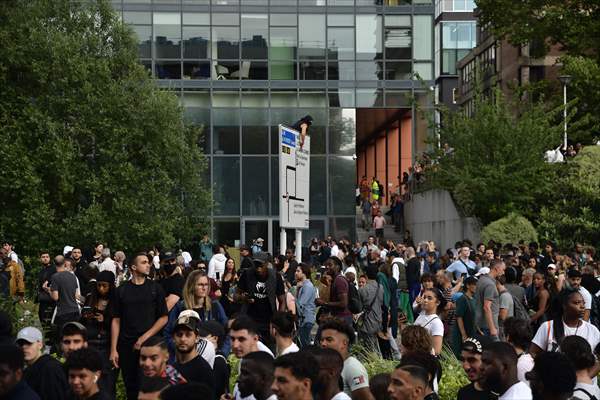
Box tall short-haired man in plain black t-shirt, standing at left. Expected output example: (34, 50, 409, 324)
(110, 253, 167, 400)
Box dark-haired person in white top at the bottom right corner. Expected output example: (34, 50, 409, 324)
(560, 336, 600, 400)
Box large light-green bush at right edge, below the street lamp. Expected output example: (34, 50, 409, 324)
(538, 146, 600, 248)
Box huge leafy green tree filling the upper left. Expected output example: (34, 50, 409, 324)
(0, 0, 209, 254)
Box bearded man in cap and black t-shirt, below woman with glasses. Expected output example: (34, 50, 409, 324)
(173, 310, 215, 393)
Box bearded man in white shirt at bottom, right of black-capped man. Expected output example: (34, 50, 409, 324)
(481, 342, 532, 400)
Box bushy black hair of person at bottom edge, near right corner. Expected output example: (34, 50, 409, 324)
(529, 351, 577, 398)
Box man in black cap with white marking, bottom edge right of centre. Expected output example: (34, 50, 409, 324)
(456, 336, 498, 400)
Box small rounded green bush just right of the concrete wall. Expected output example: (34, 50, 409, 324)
(481, 213, 538, 243)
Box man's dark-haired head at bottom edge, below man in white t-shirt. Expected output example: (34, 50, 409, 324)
(237, 351, 277, 400)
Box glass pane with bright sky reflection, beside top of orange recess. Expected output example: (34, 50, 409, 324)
(329, 108, 356, 156)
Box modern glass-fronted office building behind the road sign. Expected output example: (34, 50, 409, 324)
(112, 0, 434, 251)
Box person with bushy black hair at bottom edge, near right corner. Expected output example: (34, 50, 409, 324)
(525, 352, 577, 400)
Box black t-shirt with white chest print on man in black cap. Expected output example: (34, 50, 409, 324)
(238, 268, 285, 323)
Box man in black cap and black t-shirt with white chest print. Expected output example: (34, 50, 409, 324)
(235, 259, 286, 347)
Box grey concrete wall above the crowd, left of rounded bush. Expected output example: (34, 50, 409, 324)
(404, 190, 480, 252)
